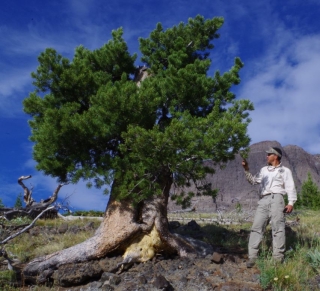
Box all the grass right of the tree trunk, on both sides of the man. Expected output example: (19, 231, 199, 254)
(170, 210, 320, 291)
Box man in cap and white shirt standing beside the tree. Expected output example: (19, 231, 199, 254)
(242, 147, 297, 268)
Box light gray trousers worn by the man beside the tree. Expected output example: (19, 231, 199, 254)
(248, 194, 286, 259)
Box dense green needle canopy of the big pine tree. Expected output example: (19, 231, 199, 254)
(23, 16, 253, 202)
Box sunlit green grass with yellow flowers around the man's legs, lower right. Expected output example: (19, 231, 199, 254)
(252, 210, 320, 291)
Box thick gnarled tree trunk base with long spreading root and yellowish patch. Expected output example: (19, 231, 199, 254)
(23, 176, 196, 283)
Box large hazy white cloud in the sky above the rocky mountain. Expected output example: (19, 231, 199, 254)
(240, 35, 320, 153)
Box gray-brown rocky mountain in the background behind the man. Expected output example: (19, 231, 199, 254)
(168, 141, 320, 212)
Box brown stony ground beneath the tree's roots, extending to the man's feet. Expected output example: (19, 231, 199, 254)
(17, 221, 262, 291)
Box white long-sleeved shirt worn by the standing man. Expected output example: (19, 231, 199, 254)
(245, 164, 297, 206)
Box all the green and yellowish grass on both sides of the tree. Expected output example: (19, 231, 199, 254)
(0, 210, 320, 291)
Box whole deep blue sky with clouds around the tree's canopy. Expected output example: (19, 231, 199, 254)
(0, 0, 320, 210)
